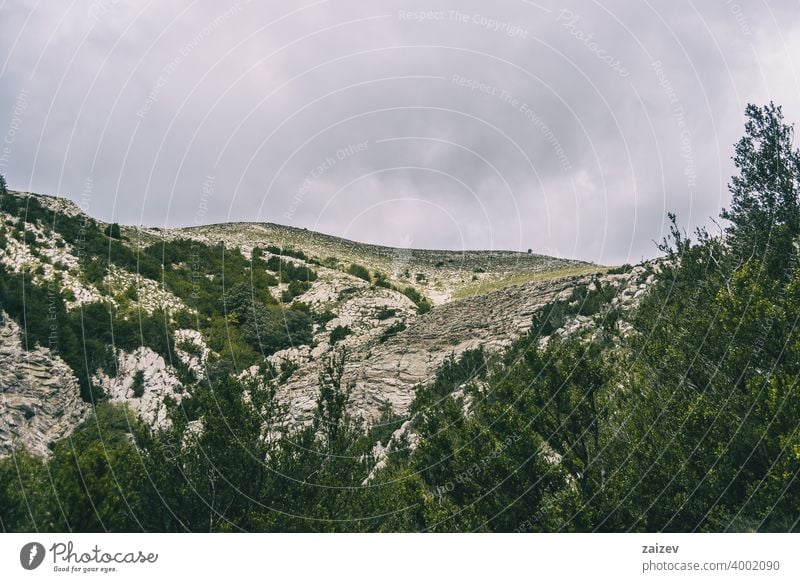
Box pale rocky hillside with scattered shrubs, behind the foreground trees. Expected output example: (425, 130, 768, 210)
(0, 192, 653, 455)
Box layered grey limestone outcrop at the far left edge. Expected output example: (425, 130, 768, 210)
(0, 313, 90, 456)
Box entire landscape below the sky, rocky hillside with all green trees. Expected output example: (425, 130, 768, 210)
(0, 104, 800, 533)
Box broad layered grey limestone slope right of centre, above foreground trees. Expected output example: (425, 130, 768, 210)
(278, 272, 639, 423)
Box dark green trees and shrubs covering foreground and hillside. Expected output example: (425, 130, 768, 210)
(0, 105, 800, 531)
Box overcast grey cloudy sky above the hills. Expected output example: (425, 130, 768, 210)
(0, 0, 800, 264)
